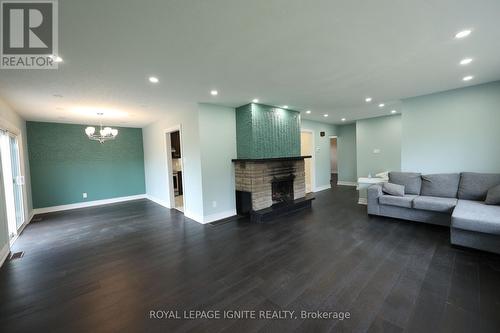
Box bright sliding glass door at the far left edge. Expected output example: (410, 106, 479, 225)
(0, 131, 25, 242)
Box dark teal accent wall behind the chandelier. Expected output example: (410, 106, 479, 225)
(26, 122, 145, 208)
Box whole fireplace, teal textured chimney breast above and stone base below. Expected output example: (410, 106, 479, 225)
(233, 103, 314, 222)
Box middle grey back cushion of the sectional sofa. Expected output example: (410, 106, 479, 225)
(420, 173, 460, 198)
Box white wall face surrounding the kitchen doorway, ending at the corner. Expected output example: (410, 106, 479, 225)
(142, 103, 203, 220)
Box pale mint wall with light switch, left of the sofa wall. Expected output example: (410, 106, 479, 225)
(356, 115, 401, 177)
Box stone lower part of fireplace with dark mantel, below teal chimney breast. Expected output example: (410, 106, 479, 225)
(233, 156, 310, 220)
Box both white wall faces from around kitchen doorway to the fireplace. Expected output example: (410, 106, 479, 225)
(143, 104, 236, 223)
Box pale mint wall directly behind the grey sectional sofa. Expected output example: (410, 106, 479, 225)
(402, 81, 500, 173)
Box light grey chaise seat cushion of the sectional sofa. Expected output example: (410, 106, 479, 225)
(451, 200, 500, 235)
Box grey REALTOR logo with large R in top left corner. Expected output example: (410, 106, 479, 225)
(0, 0, 58, 69)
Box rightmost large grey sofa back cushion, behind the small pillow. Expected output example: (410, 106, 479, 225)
(458, 172, 500, 201)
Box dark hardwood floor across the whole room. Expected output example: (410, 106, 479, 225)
(0, 186, 500, 332)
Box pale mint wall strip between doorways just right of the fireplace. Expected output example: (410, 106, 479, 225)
(301, 119, 337, 188)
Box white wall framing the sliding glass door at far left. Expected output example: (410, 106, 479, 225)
(0, 99, 33, 259)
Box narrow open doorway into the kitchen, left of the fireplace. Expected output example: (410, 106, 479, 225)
(165, 127, 185, 212)
